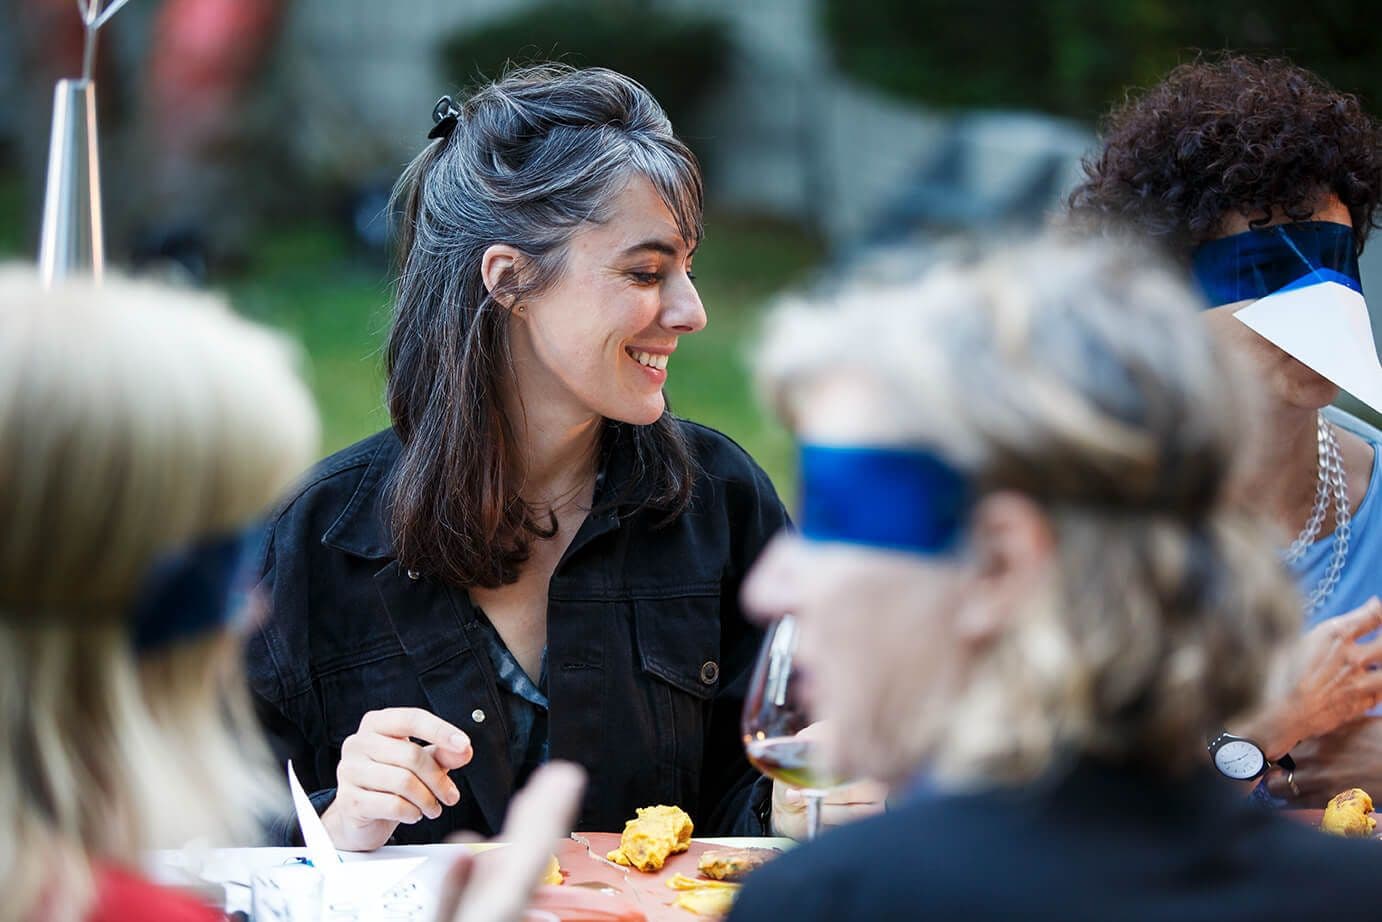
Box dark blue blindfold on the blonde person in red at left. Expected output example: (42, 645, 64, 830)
(130, 524, 265, 652)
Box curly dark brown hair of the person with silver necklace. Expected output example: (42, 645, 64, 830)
(1068, 55, 1382, 254)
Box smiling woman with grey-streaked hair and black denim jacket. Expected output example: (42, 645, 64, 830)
(249, 66, 873, 849)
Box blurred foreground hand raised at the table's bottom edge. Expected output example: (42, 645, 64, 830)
(437, 762, 586, 922)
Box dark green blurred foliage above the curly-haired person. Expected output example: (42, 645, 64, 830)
(822, 0, 1382, 119)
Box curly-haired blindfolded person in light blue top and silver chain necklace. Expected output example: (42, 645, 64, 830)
(1071, 57, 1382, 806)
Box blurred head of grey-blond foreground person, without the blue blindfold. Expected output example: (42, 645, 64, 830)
(749, 239, 1299, 784)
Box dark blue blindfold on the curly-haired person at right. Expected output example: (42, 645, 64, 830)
(1190, 221, 1363, 307)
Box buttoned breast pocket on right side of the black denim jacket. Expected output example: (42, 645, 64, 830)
(634, 585, 720, 802)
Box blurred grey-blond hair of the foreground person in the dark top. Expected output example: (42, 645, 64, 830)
(760, 238, 1300, 782)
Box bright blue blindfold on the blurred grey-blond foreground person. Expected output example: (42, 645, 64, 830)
(800, 444, 973, 556)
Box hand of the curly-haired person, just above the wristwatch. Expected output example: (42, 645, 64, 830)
(1236, 597, 1382, 759)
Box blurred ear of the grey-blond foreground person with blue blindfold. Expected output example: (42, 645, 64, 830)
(956, 492, 1056, 646)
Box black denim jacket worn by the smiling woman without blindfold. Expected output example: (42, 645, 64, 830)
(247, 422, 786, 843)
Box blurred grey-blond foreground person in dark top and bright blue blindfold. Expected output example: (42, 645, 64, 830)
(730, 241, 1382, 922)
